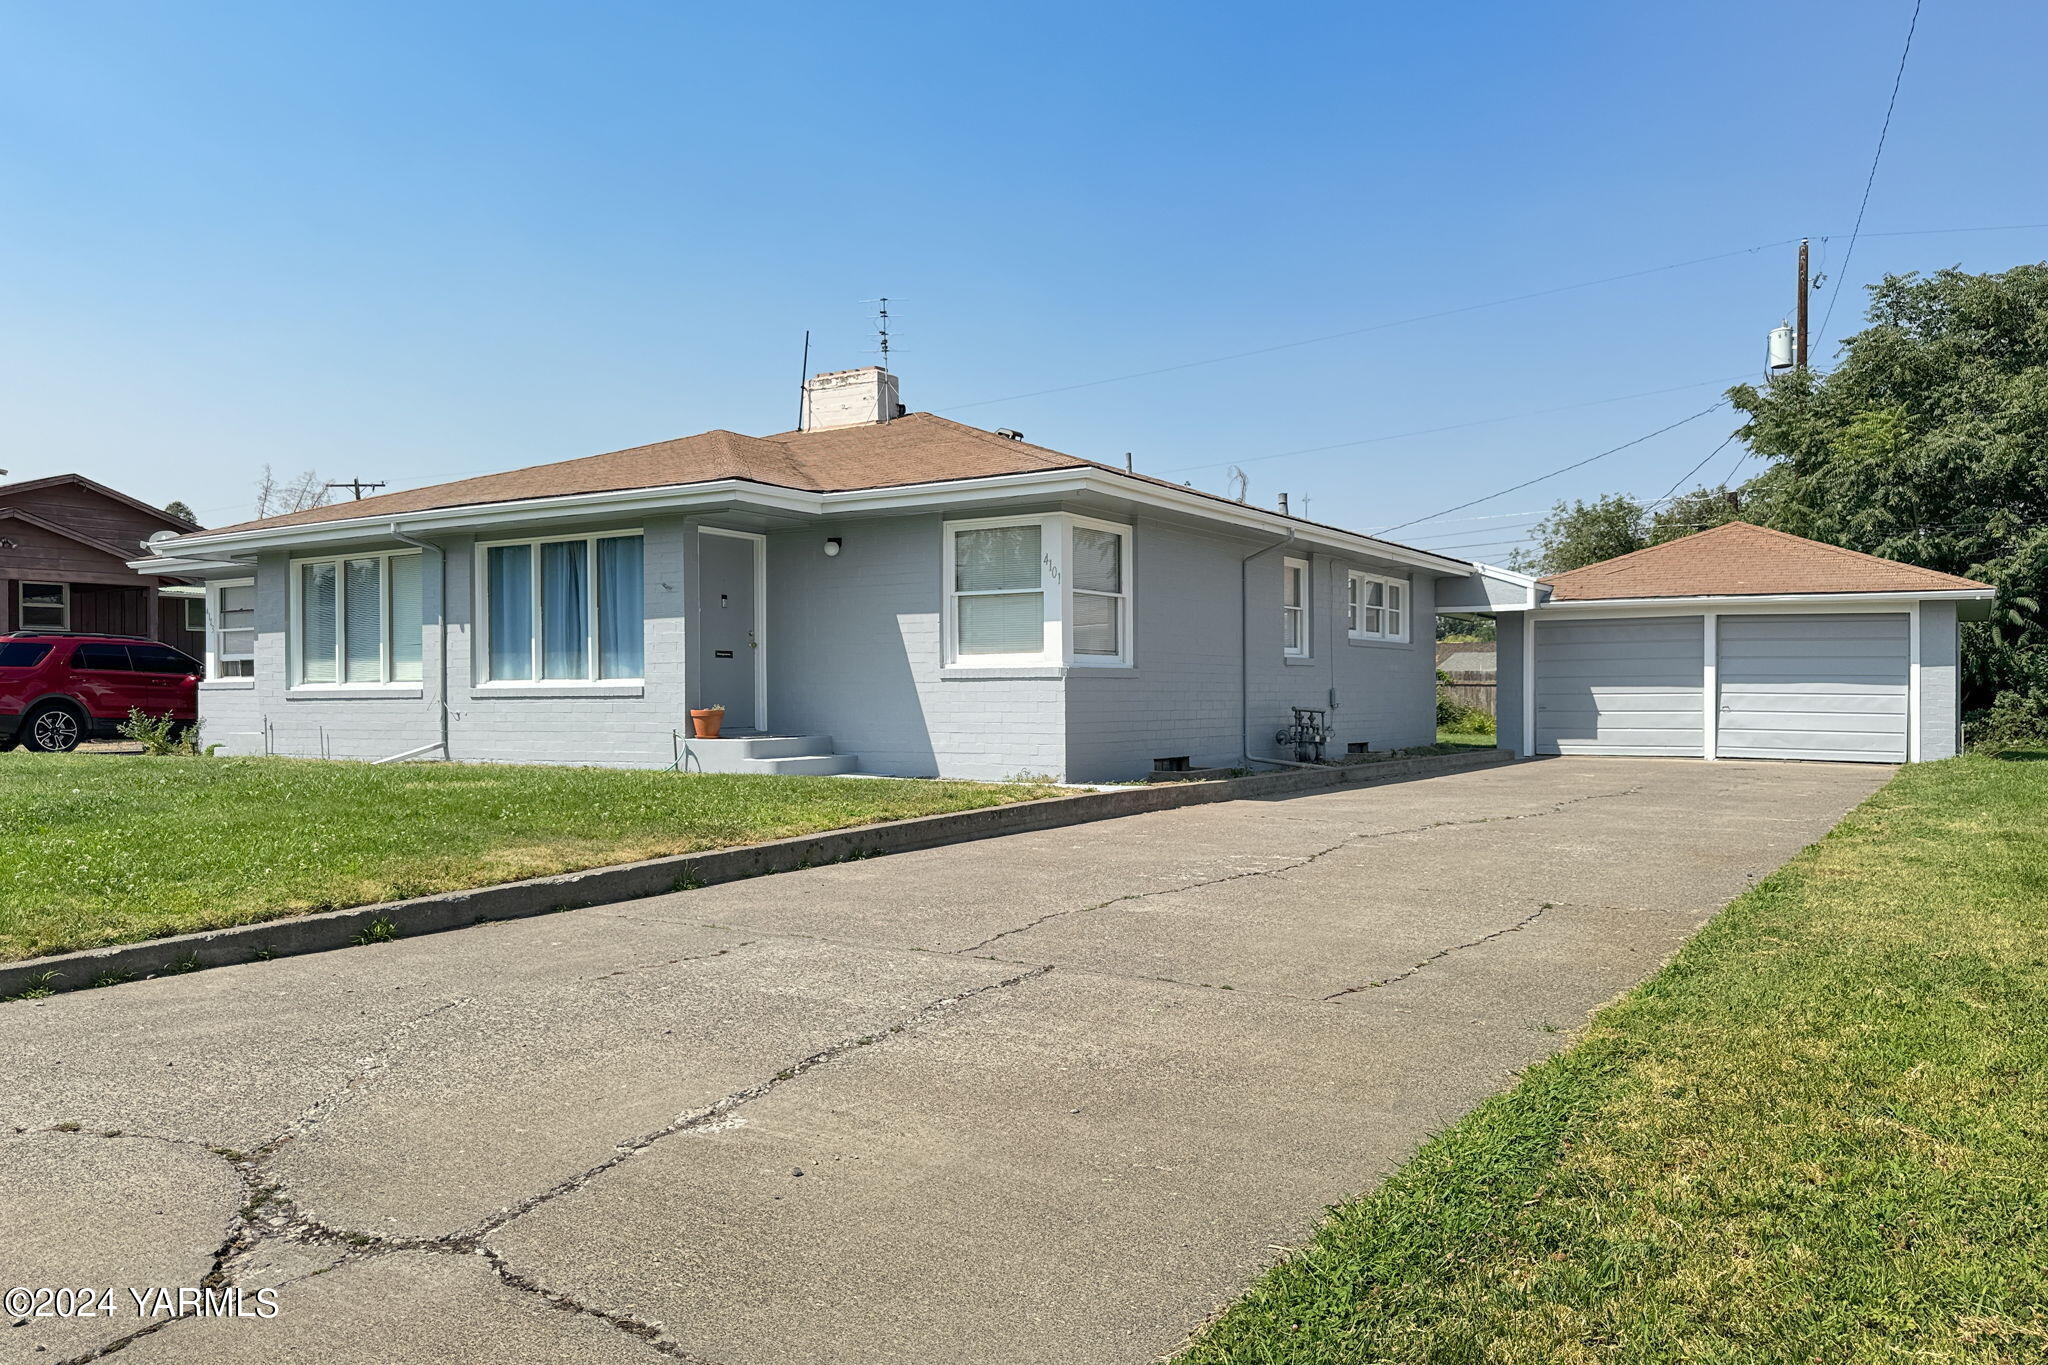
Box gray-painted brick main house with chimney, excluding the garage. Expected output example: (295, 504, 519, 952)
(136, 366, 1473, 782)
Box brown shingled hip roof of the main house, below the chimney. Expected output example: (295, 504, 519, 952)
(207, 413, 1105, 534)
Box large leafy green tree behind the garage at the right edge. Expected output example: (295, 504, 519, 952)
(1729, 264, 2048, 737)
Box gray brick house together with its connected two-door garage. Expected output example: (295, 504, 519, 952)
(135, 366, 1993, 782)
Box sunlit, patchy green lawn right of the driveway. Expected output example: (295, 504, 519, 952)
(1180, 755, 2048, 1365)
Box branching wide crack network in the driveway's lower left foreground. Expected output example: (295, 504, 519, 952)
(64, 965, 1053, 1365)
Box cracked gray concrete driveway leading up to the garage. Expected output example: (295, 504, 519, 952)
(0, 759, 1890, 1365)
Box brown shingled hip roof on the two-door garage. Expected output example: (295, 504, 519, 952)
(1538, 522, 1987, 602)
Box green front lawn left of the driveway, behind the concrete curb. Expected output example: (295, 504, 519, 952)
(0, 753, 1057, 962)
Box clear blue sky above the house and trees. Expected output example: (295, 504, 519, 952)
(0, 0, 2048, 559)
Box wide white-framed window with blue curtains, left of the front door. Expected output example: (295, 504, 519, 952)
(477, 532, 647, 684)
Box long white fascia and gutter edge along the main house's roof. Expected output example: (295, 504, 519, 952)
(137, 469, 1473, 575)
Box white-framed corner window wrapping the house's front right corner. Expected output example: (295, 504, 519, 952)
(944, 512, 1130, 667)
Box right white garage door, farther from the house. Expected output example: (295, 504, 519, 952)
(1714, 612, 1907, 763)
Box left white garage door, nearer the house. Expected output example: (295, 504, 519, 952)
(1536, 616, 1706, 759)
